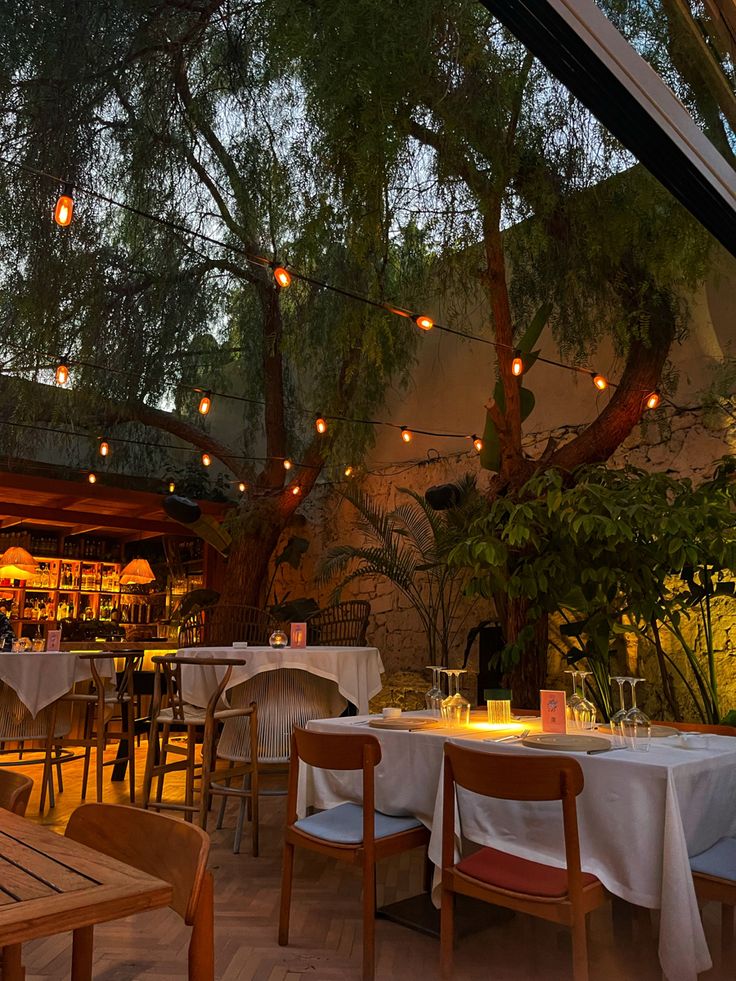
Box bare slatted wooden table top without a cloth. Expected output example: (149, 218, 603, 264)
(0, 809, 172, 947)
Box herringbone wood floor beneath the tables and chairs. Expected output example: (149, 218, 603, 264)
(2, 744, 732, 981)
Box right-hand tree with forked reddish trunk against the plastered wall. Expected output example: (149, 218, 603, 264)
(274, 0, 707, 701)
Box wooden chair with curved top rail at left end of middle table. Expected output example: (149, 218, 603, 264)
(142, 655, 245, 821)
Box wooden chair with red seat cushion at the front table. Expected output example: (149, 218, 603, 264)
(440, 743, 606, 981)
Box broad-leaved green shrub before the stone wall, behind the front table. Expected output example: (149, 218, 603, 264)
(450, 465, 736, 721)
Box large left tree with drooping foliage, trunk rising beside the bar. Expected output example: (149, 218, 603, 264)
(0, 0, 425, 604)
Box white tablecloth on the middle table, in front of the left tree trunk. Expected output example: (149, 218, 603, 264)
(178, 647, 383, 712)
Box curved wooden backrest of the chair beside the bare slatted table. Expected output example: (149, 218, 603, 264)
(64, 804, 210, 925)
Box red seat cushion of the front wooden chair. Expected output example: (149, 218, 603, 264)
(455, 848, 598, 899)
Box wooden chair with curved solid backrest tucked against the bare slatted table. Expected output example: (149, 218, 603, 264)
(65, 804, 215, 981)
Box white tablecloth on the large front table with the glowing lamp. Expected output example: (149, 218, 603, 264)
(299, 718, 736, 981)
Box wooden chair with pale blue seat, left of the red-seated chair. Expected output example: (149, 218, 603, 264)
(279, 727, 429, 981)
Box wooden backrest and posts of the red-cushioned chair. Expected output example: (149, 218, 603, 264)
(442, 743, 584, 901)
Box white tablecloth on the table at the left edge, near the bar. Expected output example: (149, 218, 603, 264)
(0, 651, 115, 719)
